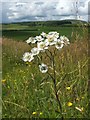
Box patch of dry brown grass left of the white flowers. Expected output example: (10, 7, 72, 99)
(2, 38, 30, 60)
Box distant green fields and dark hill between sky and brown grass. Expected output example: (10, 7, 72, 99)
(0, 20, 88, 41)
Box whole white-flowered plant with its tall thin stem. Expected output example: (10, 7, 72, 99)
(22, 31, 70, 119)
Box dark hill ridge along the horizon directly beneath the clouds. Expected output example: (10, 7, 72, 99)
(4, 19, 87, 26)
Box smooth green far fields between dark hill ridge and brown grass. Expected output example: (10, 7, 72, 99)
(2, 23, 87, 41)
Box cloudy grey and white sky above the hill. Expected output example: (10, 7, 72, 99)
(0, 0, 90, 23)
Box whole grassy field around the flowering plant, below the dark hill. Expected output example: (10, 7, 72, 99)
(2, 21, 89, 118)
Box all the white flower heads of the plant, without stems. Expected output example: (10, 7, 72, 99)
(22, 32, 70, 73)
